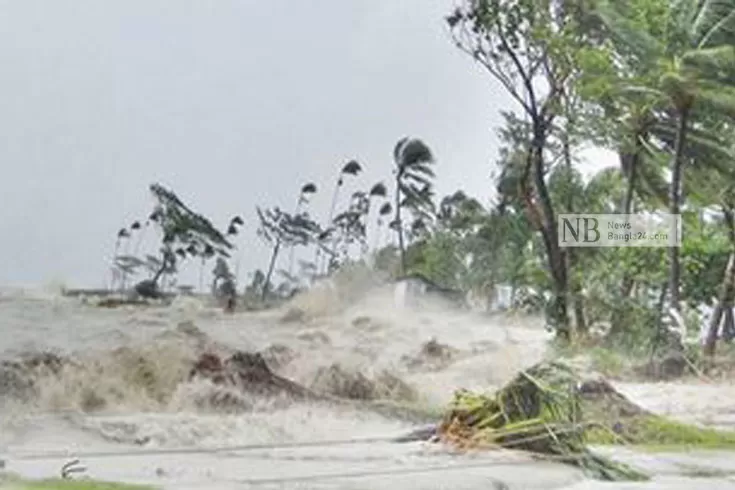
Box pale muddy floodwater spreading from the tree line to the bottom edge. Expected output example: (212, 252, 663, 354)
(0, 290, 735, 490)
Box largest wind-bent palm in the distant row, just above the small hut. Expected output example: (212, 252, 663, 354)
(393, 137, 434, 275)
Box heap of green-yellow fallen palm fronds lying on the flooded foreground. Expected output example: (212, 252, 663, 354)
(439, 362, 648, 481)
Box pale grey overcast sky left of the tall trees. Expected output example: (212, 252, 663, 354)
(0, 0, 616, 287)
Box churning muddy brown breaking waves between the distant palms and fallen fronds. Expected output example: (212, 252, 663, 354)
(0, 286, 543, 445)
